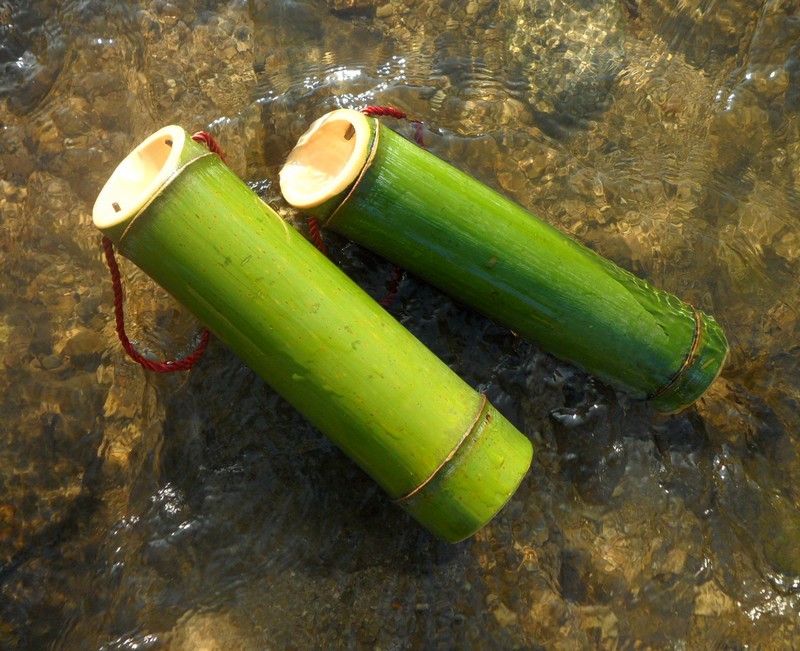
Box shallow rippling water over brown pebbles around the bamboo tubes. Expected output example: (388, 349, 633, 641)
(0, 0, 800, 649)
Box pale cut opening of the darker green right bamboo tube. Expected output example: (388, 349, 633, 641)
(280, 109, 372, 209)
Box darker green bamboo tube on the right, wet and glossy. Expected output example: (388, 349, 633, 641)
(280, 109, 728, 412)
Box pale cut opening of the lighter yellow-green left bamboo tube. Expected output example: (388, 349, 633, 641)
(92, 125, 186, 230)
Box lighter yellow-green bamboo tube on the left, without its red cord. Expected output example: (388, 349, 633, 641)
(93, 126, 532, 542)
